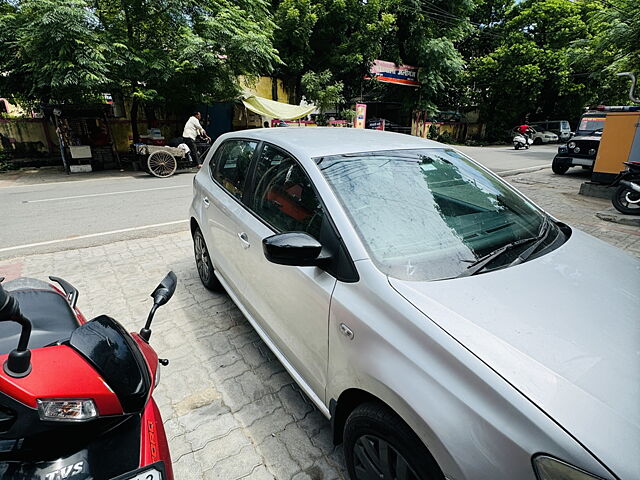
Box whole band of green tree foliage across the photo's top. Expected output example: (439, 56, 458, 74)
(0, 0, 640, 138)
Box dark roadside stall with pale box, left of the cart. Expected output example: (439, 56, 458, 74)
(43, 104, 121, 173)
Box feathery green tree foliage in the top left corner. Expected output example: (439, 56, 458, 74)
(0, 0, 111, 103)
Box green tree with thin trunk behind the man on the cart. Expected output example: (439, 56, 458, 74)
(95, 0, 278, 139)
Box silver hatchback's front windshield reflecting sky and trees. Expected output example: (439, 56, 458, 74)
(316, 148, 544, 281)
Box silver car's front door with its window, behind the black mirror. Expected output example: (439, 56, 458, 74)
(232, 144, 336, 402)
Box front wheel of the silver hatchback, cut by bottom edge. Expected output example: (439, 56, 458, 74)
(343, 402, 444, 480)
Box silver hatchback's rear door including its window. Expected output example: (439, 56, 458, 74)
(202, 139, 258, 301)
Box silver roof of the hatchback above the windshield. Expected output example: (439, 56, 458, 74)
(225, 127, 446, 158)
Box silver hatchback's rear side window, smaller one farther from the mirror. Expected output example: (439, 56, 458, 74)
(213, 140, 258, 199)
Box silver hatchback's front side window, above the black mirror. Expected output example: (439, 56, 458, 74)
(250, 145, 325, 239)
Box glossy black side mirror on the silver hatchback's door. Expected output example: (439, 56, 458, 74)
(262, 232, 329, 267)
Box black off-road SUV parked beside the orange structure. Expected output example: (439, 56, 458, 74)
(551, 112, 607, 175)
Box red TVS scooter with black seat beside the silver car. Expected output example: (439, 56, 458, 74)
(0, 272, 177, 480)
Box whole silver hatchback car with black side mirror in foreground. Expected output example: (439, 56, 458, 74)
(190, 128, 640, 480)
